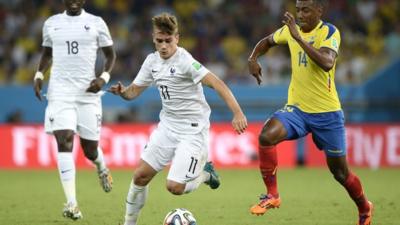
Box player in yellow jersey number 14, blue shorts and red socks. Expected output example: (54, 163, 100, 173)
(248, 0, 373, 225)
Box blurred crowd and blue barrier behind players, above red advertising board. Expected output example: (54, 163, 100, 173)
(0, 0, 400, 123)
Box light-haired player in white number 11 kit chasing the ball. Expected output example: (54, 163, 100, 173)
(109, 13, 247, 225)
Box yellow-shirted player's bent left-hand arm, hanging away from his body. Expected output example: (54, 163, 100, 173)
(248, 34, 276, 85)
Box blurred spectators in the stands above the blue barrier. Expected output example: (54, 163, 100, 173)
(0, 0, 400, 85)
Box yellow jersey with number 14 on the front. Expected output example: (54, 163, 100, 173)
(273, 21, 341, 113)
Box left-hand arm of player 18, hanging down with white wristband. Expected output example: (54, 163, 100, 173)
(33, 47, 53, 101)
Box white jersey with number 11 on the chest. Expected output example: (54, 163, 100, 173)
(133, 48, 211, 134)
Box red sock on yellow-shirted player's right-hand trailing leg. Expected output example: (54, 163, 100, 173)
(343, 172, 369, 214)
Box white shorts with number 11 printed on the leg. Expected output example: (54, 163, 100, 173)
(141, 124, 209, 184)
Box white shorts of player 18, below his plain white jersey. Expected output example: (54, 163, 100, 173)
(44, 98, 102, 141)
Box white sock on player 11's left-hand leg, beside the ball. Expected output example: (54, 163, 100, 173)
(124, 180, 148, 225)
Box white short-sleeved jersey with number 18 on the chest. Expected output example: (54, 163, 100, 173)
(42, 10, 113, 99)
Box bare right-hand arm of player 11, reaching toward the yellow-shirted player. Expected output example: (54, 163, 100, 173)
(201, 72, 247, 134)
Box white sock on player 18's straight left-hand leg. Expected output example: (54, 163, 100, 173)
(57, 152, 77, 205)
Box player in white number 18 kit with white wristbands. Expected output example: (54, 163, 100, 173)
(34, 0, 116, 220)
